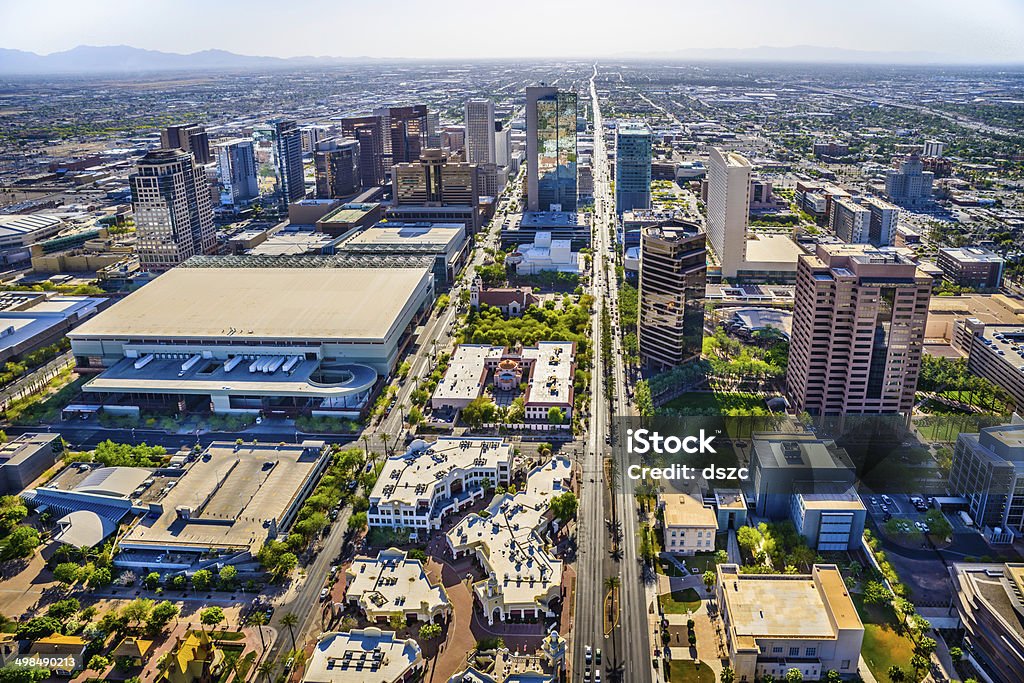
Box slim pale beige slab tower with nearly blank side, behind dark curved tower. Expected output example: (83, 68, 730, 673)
(707, 147, 753, 278)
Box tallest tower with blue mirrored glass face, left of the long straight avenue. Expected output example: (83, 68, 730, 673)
(526, 86, 577, 211)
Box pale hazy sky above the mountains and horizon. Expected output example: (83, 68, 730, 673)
(0, 0, 1024, 62)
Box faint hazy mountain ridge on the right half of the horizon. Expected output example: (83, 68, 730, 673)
(615, 45, 964, 65)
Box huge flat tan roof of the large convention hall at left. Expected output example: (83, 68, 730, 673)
(71, 267, 430, 343)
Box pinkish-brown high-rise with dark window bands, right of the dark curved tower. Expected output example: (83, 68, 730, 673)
(786, 244, 932, 416)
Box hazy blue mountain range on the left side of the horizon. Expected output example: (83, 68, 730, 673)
(0, 45, 380, 74)
